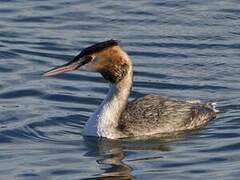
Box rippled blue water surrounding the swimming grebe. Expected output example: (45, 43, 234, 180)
(0, 0, 240, 180)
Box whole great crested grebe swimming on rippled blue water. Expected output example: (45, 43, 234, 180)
(44, 40, 217, 139)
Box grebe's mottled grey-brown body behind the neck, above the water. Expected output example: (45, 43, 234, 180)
(118, 95, 216, 136)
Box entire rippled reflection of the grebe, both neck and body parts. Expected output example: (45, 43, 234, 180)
(84, 131, 191, 179)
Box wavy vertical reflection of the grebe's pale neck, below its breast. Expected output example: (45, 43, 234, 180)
(84, 137, 134, 179)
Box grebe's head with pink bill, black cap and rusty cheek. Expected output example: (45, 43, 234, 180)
(44, 40, 131, 83)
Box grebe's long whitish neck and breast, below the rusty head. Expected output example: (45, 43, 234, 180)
(84, 58, 133, 139)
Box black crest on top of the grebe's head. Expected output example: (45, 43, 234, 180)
(78, 39, 119, 58)
